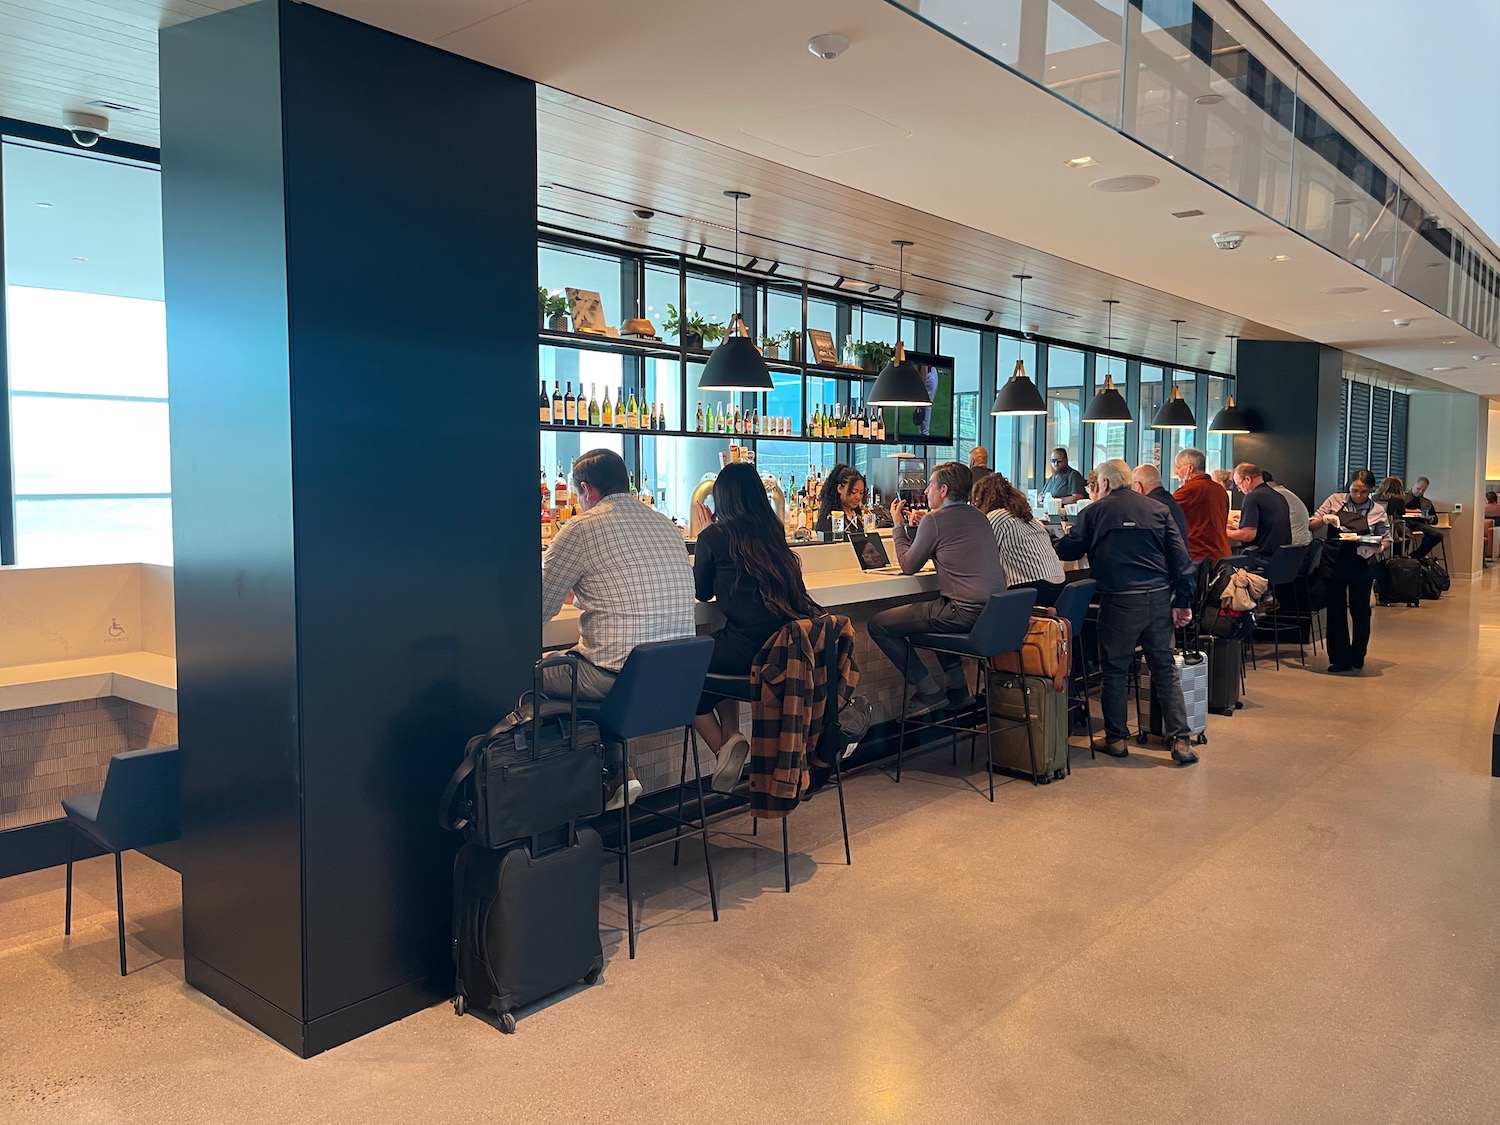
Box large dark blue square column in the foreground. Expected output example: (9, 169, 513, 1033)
(161, 0, 540, 1055)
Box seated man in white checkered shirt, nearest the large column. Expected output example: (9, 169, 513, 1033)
(542, 450, 696, 809)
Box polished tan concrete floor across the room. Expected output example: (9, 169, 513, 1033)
(0, 575, 1500, 1125)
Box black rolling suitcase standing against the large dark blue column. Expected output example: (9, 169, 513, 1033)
(453, 827, 605, 1034)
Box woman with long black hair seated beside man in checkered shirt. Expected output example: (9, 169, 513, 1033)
(690, 462, 822, 792)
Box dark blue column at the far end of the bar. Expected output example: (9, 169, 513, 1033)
(1235, 341, 1344, 509)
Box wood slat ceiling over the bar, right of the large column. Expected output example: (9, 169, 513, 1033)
(537, 89, 1299, 372)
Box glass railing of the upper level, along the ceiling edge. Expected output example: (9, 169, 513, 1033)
(888, 0, 1500, 344)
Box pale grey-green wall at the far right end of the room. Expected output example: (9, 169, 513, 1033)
(1407, 392, 1490, 578)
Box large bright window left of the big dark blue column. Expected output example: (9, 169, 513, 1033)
(0, 141, 173, 566)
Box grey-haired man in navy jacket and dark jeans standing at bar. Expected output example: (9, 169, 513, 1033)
(1056, 461, 1199, 765)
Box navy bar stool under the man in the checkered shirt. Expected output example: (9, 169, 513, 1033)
(578, 636, 719, 957)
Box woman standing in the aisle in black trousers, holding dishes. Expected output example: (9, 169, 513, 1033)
(1313, 470, 1391, 675)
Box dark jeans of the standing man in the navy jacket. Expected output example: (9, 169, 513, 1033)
(1098, 590, 1188, 740)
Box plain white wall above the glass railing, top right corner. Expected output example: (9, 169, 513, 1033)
(1265, 0, 1500, 240)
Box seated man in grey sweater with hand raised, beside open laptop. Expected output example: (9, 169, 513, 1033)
(870, 461, 1005, 717)
